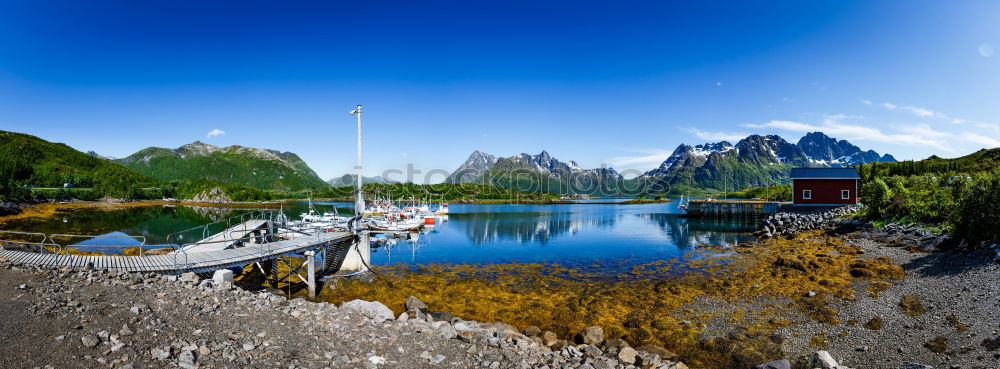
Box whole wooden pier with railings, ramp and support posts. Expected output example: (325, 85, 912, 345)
(0, 213, 371, 296)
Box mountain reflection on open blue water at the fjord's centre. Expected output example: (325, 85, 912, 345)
(449, 212, 616, 245)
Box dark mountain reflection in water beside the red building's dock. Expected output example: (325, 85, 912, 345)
(638, 213, 754, 250)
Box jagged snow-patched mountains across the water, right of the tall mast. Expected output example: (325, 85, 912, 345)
(447, 132, 896, 196)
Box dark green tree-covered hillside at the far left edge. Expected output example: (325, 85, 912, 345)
(0, 131, 157, 200)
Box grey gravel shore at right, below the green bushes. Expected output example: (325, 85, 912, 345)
(781, 231, 1000, 369)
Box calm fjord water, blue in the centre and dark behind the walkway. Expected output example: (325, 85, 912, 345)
(2, 202, 753, 269)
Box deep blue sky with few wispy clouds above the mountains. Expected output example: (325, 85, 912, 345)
(0, 1, 1000, 180)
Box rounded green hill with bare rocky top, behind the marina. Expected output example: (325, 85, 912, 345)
(117, 142, 329, 191)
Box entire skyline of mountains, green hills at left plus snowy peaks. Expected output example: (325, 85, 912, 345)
(0, 131, 908, 200)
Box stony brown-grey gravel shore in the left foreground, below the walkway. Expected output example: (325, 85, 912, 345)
(0, 261, 687, 369)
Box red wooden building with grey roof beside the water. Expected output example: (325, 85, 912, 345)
(792, 168, 861, 206)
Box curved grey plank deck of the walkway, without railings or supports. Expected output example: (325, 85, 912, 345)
(0, 232, 354, 273)
